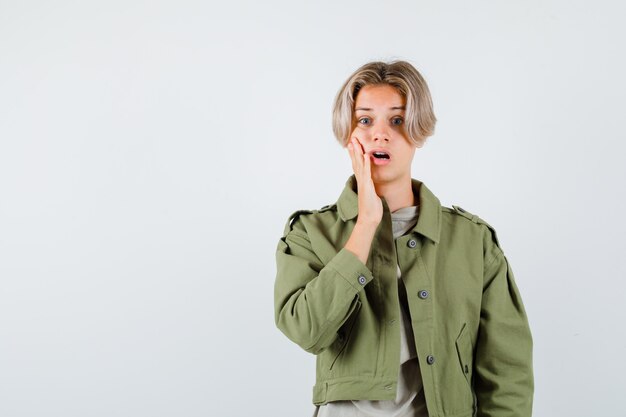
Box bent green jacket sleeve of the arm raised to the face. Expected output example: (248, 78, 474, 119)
(274, 213, 373, 354)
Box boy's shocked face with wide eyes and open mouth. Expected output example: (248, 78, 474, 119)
(350, 84, 417, 183)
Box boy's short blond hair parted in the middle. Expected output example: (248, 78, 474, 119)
(333, 60, 437, 147)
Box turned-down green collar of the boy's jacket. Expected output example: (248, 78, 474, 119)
(337, 174, 441, 243)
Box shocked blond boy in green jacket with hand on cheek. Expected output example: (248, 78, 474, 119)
(274, 61, 534, 417)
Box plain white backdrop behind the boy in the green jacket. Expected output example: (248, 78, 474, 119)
(0, 0, 626, 417)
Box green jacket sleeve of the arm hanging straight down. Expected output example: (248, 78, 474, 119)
(474, 228, 534, 417)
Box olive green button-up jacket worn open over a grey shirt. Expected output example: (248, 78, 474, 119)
(274, 175, 534, 417)
